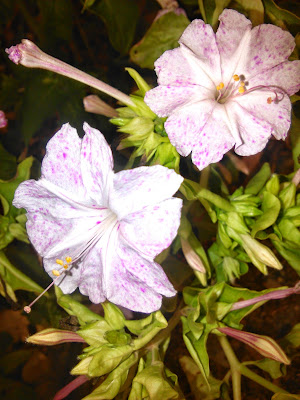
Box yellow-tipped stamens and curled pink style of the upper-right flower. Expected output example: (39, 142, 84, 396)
(216, 74, 286, 104)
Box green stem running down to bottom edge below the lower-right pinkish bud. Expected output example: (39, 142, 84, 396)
(218, 336, 242, 400)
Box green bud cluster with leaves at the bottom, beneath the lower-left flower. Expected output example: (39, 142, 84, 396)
(27, 288, 180, 400)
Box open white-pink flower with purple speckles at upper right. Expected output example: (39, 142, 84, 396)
(145, 9, 300, 170)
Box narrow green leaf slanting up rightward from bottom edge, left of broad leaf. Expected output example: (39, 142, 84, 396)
(82, 354, 138, 400)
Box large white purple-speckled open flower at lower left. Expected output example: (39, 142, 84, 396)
(13, 123, 183, 313)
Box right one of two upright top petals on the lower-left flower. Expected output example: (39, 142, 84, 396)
(81, 122, 113, 206)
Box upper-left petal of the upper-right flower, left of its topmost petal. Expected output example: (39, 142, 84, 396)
(178, 19, 221, 86)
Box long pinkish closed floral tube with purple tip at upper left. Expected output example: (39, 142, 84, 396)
(5, 39, 134, 106)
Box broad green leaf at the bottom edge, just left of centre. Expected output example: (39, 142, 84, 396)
(133, 361, 180, 400)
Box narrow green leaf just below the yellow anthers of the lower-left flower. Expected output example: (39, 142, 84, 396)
(55, 286, 103, 325)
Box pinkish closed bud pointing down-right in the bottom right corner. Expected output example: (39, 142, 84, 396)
(218, 327, 290, 364)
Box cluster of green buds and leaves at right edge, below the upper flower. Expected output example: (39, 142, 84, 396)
(181, 164, 300, 284)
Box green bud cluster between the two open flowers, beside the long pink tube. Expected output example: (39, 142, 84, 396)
(110, 68, 180, 172)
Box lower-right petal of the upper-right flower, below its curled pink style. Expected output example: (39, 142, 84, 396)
(230, 102, 272, 156)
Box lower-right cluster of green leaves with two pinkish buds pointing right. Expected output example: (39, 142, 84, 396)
(181, 282, 292, 388)
